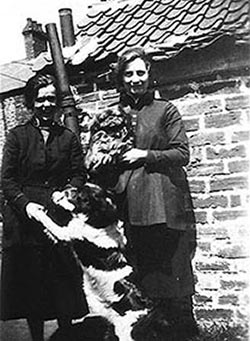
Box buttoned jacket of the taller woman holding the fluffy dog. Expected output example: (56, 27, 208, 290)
(118, 93, 194, 230)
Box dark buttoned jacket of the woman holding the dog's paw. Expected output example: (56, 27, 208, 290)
(2, 118, 86, 246)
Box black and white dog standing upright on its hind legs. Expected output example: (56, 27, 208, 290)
(39, 183, 169, 341)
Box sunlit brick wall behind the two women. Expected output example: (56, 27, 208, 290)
(0, 78, 250, 324)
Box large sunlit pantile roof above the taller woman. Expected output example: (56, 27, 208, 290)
(77, 0, 250, 59)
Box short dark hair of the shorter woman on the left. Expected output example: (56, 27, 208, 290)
(24, 73, 59, 109)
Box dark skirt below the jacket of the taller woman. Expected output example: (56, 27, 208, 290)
(126, 224, 194, 299)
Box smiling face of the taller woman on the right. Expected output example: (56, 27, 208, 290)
(123, 58, 149, 98)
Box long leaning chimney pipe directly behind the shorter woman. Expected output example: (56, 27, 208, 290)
(45, 23, 80, 138)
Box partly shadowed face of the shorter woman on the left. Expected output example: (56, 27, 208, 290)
(34, 84, 57, 120)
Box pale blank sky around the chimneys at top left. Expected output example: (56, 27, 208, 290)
(0, 0, 93, 64)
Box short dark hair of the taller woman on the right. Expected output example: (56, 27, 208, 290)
(116, 47, 151, 91)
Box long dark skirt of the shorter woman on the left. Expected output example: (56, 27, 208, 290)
(1, 243, 88, 320)
